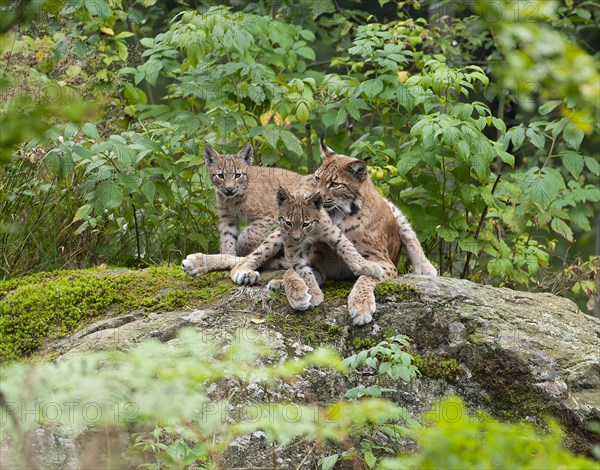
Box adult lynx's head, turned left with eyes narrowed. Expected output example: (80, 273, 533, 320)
(314, 143, 367, 217)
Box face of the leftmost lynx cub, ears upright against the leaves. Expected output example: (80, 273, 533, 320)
(204, 142, 253, 197)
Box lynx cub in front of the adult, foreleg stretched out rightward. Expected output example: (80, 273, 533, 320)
(268, 188, 383, 310)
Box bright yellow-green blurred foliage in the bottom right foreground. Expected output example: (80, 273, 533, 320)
(380, 398, 598, 470)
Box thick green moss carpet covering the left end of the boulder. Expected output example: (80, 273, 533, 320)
(0, 267, 234, 361)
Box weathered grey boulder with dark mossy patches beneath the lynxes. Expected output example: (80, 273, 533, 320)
(4, 275, 600, 468)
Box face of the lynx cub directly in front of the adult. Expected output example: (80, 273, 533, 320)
(277, 188, 323, 241)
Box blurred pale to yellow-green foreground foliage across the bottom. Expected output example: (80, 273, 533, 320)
(0, 328, 596, 469)
